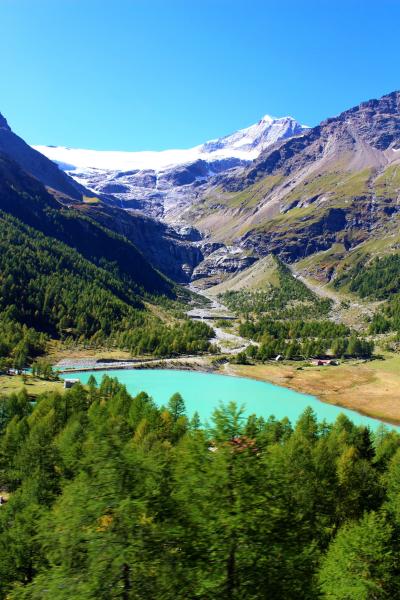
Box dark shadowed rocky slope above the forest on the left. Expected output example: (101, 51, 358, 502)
(0, 110, 213, 283)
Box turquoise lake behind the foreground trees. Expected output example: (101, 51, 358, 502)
(61, 369, 400, 431)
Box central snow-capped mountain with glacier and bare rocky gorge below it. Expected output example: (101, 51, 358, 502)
(28, 116, 307, 283)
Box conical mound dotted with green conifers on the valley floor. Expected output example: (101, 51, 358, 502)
(221, 256, 374, 361)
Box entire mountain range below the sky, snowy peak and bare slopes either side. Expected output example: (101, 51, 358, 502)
(0, 92, 400, 292)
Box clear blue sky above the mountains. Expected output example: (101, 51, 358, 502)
(0, 0, 400, 150)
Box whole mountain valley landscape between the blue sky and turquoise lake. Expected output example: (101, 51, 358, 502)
(0, 92, 400, 408)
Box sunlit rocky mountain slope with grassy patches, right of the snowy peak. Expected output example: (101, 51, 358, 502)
(182, 92, 400, 282)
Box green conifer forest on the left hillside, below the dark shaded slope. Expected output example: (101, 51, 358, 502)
(0, 193, 213, 360)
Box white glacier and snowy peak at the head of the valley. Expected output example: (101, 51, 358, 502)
(34, 115, 306, 218)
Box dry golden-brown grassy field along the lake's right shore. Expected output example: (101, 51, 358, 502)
(225, 354, 400, 425)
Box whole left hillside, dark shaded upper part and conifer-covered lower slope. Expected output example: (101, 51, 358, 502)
(0, 152, 217, 368)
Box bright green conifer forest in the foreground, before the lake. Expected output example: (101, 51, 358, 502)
(0, 377, 400, 600)
